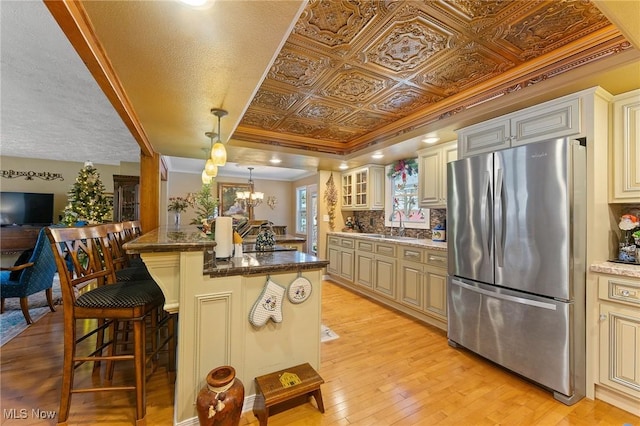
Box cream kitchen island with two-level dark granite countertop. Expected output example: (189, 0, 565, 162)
(125, 227, 328, 424)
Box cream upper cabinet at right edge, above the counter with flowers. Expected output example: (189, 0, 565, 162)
(609, 89, 640, 203)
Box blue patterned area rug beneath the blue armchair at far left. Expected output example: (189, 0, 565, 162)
(0, 274, 62, 346)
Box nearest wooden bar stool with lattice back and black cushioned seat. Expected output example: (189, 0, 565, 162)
(46, 226, 164, 425)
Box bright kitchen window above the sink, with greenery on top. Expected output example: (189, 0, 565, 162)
(384, 158, 430, 229)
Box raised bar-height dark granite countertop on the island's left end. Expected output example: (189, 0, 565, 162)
(124, 225, 216, 254)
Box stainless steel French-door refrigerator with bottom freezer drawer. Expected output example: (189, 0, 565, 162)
(447, 139, 584, 405)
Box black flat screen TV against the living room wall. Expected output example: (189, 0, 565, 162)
(0, 192, 53, 226)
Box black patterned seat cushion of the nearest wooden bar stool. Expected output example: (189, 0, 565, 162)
(76, 281, 164, 309)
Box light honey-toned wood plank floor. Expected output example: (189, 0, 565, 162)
(0, 282, 640, 426)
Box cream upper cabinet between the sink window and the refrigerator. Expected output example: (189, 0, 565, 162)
(418, 141, 458, 208)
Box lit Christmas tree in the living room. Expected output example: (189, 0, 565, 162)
(62, 162, 112, 226)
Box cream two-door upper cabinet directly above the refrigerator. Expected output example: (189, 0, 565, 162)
(458, 95, 581, 158)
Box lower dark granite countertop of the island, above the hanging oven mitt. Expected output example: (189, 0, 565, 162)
(204, 251, 329, 277)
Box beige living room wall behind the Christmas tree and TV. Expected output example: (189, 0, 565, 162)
(0, 156, 139, 222)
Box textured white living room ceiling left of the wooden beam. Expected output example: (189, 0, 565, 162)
(0, 1, 140, 165)
